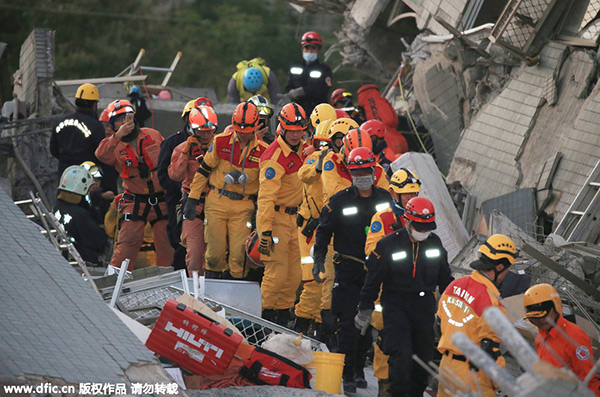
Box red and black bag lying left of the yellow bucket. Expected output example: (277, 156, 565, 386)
(240, 347, 311, 389)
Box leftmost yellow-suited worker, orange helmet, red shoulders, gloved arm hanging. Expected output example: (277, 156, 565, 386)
(183, 102, 267, 279)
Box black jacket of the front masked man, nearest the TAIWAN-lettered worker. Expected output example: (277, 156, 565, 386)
(358, 228, 454, 309)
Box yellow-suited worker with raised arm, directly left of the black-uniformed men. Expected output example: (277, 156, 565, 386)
(294, 120, 334, 335)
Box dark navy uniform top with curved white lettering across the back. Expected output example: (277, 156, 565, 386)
(50, 109, 106, 175)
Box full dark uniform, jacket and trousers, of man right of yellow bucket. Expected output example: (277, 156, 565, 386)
(314, 186, 391, 381)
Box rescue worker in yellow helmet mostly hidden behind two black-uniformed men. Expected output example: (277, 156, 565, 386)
(365, 168, 421, 396)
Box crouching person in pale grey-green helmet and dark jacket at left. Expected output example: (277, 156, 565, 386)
(54, 165, 106, 265)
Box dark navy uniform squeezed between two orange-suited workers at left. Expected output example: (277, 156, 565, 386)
(156, 130, 189, 269)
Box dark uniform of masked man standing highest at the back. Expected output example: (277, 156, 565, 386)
(285, 60, 332, 115)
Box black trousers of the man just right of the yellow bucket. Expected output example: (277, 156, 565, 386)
(331, 259, 373, 380)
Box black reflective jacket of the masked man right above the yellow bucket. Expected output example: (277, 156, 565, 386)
(314, 186, 392, 262)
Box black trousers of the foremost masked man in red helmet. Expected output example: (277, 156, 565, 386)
(381, 293, 436, 397)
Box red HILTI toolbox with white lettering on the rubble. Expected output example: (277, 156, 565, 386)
(146, 299, 243, 375)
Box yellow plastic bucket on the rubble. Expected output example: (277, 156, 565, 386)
(305, 352, 346, 394)
